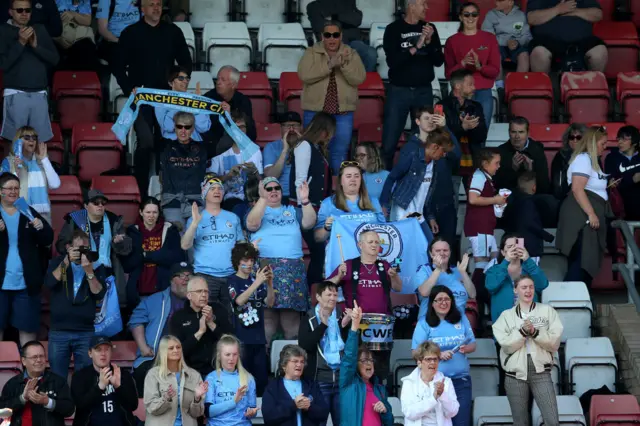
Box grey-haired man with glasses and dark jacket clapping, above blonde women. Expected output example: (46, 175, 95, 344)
(169, 275, 231, 377)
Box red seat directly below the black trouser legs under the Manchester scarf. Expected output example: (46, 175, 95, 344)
(91, 176, 140, 225)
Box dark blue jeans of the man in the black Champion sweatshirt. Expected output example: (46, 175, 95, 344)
(382, 84, 433, 170)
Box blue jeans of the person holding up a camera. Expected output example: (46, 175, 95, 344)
(49, 331, 94, 379)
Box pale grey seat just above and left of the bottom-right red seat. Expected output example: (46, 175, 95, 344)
(564, 337, 618, 397)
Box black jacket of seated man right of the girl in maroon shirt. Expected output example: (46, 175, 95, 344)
(495, 138, 550, 194)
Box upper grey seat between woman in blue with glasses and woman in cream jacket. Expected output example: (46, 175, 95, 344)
(467, 339, 500, 398)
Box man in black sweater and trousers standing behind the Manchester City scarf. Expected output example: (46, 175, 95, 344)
(113, 0, 192, 194)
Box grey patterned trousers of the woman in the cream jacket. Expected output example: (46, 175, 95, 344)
(504, 355, 560, 426)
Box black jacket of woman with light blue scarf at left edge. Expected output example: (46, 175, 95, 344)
(0, 208, 53, 296)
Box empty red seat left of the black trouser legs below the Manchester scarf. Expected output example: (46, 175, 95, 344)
(71, 123, 123, 182)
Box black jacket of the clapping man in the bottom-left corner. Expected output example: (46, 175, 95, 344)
(0, 371, 76, 426)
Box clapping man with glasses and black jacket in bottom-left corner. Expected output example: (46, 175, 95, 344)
(0, 340, 75, 426)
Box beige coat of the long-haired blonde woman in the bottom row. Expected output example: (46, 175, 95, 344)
(144, 367, 204, 426)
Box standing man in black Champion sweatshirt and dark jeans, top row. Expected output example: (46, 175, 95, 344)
(382, 0, 444, 170)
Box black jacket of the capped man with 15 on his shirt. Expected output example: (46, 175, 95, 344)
(71, 364, 138, 426)
